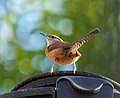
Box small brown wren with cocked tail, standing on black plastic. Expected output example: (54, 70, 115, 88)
(40, 28, 100, 73)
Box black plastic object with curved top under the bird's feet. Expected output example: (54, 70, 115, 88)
(0, 71, 120, 98)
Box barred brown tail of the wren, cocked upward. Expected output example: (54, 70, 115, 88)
(73, 28, 100, 49)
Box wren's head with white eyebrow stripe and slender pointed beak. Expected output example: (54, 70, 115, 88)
(40, 33, 63, 46)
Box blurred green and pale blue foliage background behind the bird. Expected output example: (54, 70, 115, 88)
(0, 0, 120, 94)
